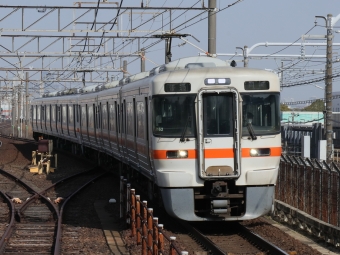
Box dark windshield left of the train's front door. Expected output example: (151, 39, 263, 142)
(152, 94, 196, 137)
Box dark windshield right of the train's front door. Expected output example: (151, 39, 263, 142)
(241, 93, 280, 136)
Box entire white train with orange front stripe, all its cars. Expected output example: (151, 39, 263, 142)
(32, 57, 281, 221)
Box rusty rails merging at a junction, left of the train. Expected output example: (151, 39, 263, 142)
(0, 169, 105, 254)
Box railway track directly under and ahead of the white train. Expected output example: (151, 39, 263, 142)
(132, 182, 288, 255)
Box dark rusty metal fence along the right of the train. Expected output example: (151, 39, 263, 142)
(275, 155, 340, 227)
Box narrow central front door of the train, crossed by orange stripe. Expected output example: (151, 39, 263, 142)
(198, 88, 240, 178)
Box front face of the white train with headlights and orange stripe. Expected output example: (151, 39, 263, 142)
(151, 58, 281, 221)
